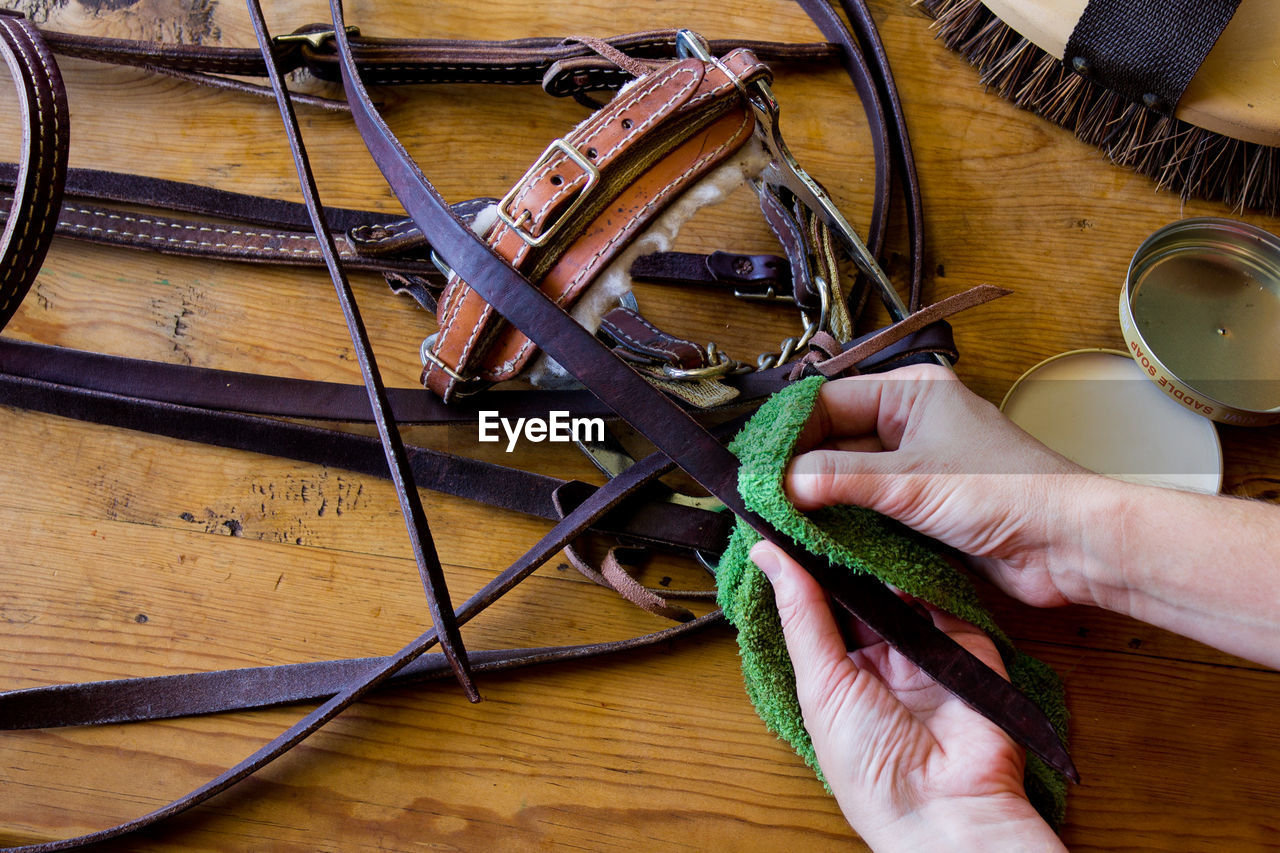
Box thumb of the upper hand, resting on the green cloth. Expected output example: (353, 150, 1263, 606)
(785, 450, 904, 512)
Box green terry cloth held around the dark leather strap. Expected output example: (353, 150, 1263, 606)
(716, 377, 1068, 827)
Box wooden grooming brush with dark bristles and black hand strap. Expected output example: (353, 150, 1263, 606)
(916, 0, 1280, 216)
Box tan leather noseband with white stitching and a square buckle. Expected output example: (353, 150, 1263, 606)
(422, 50, 765, 402)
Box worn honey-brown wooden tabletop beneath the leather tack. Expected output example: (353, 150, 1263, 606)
(0, 0, 1280, 852)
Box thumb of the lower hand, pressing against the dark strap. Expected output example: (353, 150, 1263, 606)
(751, 542, 852, 707)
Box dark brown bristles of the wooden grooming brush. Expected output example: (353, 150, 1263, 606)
(916, 0, 1280, 216)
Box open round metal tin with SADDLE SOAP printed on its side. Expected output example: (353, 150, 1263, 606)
(1120, 218, 1280, 427)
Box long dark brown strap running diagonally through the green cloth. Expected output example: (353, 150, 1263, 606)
(330, 0, 1075, 776)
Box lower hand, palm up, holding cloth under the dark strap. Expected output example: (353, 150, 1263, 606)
(751, 542, 1061, 852)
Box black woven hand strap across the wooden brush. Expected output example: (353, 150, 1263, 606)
(1066, 0, 1240, 115)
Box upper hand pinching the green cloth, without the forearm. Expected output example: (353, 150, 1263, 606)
(786, 365, 1110, 607)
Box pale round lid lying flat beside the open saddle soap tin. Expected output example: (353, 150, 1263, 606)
(1000, 350, 1222, 493)
